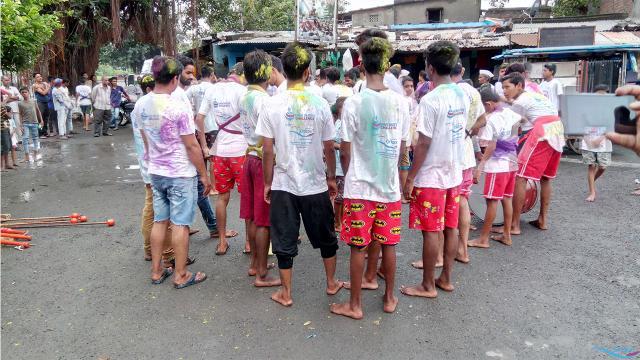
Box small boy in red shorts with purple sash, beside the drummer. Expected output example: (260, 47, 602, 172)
(468, 88, 521, 248)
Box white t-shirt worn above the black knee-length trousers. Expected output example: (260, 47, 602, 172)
(256, 89, 335, 196)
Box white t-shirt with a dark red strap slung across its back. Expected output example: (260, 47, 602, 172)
(198, 81, 247, 157)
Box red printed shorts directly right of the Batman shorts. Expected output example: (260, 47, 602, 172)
(409, 186, 460, 232)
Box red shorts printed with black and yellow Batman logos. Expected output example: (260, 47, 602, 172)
(340, 199, 402, 247)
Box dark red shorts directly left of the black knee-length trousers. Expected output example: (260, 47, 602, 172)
(240, 155, 271, 226)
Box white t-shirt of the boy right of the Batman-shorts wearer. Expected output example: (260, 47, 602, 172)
(414, 83, 470, 189)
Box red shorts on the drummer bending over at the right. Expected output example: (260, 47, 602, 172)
(517, 141, 562, 181)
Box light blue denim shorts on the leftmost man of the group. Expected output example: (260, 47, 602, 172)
(151, 174, 198, 226)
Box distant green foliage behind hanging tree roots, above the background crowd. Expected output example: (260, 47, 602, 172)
(100, 38, 160, 73)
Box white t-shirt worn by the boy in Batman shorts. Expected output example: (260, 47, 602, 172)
(342, 89, 411, 203)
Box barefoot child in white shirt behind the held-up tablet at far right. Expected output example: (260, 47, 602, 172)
(581, 85, 612, 202)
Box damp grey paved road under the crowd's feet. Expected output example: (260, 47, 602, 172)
(1, 129, 640, 359)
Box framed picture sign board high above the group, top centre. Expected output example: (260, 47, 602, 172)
(296, 0, 337, 45)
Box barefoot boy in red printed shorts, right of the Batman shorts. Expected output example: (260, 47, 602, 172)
(401, 41, 470, 298)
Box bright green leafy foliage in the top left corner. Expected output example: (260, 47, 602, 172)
(0, 0, 65, 71)
